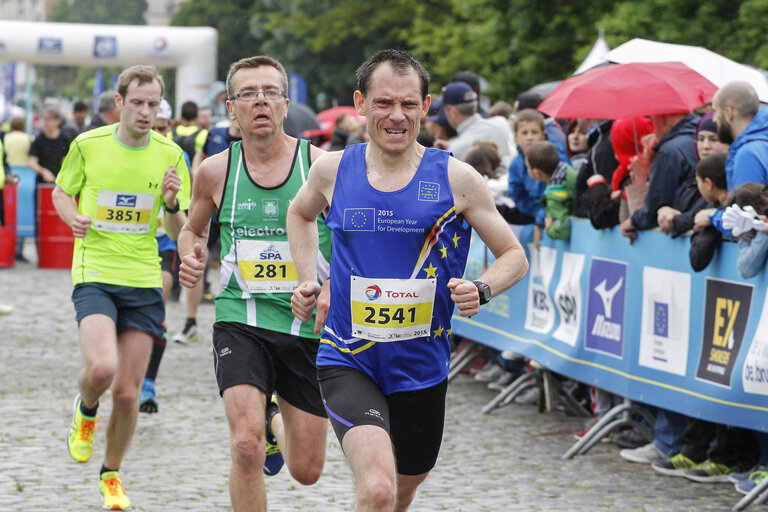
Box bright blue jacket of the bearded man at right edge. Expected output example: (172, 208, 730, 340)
(725, 108, 768, 192)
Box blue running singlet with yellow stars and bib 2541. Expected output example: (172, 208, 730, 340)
(317, 144, 471, 395)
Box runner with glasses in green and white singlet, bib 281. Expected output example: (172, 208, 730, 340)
(179, 56, 330, 511)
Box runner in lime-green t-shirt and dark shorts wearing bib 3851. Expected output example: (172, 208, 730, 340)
(53, 66, 190, 510)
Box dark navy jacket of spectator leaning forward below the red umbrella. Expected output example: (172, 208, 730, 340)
(631, 114, 699, 230)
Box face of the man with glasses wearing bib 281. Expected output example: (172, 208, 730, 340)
(227, 66, 288, 137)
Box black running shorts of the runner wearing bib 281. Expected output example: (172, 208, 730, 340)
(213, 322, 326, 418)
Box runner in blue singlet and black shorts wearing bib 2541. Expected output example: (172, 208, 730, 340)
(288, 50, 528, 511)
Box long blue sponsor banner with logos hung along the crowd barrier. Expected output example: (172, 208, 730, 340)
(453, 220, 768, 431)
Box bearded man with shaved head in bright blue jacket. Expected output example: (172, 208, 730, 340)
(712, 82, 768, 190)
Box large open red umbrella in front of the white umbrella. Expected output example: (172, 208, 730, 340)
(539, 62, 717, 119)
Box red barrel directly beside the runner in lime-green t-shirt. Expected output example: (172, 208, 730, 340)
(37, 183, 75, 268)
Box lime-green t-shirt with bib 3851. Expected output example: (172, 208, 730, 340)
(56, 124, 190, 288)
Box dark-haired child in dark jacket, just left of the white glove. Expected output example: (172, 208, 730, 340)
(688, 153, 728, 272)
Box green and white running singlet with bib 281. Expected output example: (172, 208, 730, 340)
(215, 139, 331, 338)
